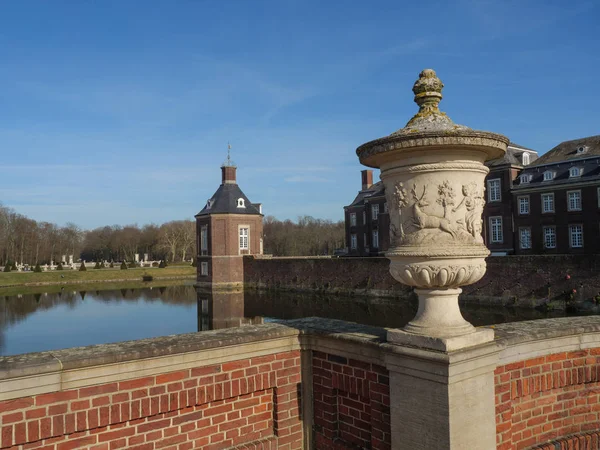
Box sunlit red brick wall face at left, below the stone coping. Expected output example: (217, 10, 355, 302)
(0, 351, 303, 450)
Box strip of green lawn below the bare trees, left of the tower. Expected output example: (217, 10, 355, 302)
(0, 265, 196, 289)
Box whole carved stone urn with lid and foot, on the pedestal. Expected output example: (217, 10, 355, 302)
(356, 69, 509, 351)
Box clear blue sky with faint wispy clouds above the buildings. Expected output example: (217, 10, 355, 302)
(0, 0, 600, 228)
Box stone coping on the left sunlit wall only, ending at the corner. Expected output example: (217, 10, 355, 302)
(0, 324, 298, 380)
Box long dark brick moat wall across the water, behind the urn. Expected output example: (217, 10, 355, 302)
(244, 255, 600, 308)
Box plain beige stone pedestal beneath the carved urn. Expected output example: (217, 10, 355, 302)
(386, 343, 499, 450)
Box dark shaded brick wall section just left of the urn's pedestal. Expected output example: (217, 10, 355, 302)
(313, 352, 391, 450)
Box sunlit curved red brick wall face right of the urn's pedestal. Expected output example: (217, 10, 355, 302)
(495, 349, 600, 450)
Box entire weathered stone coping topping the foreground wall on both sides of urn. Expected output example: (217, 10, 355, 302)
(0, 316, 600, 380)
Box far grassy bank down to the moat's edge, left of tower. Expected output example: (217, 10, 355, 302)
(0, 265, 196, 295)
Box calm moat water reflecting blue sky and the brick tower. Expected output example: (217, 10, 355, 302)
(0, 285, 580, 355)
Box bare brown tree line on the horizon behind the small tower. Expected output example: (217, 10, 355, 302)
(0, 205, 345, 265)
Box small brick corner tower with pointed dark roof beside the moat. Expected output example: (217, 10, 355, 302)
(195, 156, 263, 285)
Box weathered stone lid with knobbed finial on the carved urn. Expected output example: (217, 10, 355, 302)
(356, 69, 509, 167)
